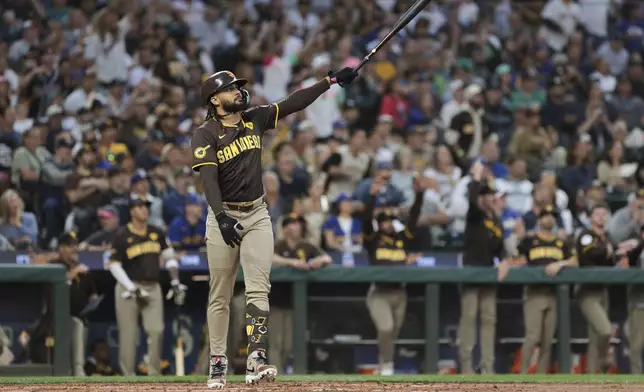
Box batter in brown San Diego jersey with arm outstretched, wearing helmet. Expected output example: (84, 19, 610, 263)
(192, 68, 358, 388)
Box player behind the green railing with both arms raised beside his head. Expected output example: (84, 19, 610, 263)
(362, 176, 426, 376)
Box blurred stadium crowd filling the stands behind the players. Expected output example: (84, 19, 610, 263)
(0, 0, 644, 376)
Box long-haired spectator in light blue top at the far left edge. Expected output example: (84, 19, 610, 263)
(0, 189, 38, 251)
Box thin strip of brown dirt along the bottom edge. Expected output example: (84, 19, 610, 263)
(0, 382, 642, 392)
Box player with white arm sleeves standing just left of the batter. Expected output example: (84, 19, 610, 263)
(109, 198, 186, 376)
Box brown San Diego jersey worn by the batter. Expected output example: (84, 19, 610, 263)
(192, 103, 279, 202)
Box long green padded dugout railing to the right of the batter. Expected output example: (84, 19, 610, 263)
(237, 266, 644, 374)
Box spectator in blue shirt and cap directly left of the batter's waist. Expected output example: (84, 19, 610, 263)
(168, 194, 206, 251)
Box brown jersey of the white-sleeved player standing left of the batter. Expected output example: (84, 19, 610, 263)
(110, 223, 168, 282)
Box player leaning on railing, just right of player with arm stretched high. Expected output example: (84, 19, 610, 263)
(499, 205, 576, 374)
